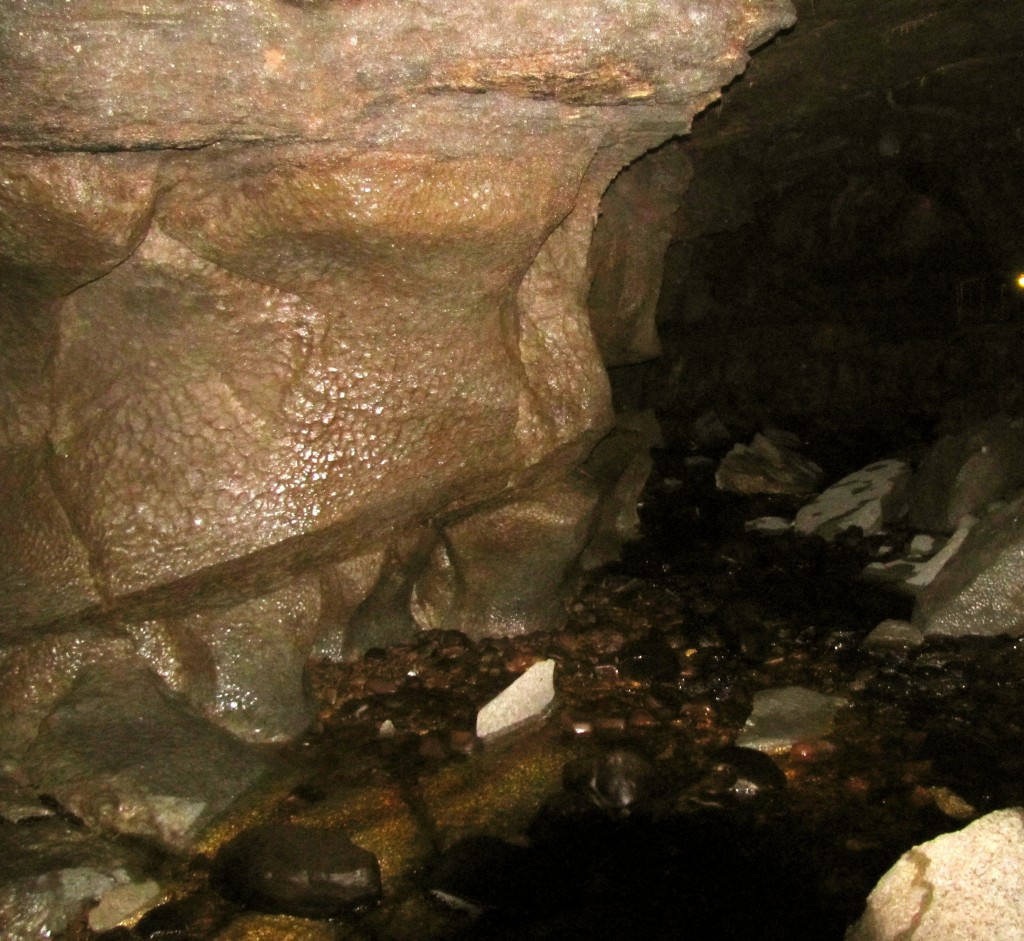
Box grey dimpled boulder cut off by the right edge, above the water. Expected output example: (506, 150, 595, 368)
(913, 497, 1024, 636)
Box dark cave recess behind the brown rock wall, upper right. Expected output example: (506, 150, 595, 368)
(611, 0, 1024, 445)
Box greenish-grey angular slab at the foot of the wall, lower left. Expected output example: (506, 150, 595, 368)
(24, 668, 272, 850)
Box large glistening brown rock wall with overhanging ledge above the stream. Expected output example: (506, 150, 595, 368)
(0, 0, 793, 738)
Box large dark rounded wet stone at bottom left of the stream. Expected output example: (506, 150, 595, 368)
(212, 823, 381, 918)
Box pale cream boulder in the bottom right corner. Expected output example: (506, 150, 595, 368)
(846, 807, 1024, 941)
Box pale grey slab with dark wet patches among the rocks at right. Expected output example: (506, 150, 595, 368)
(794, 460, 910, 540)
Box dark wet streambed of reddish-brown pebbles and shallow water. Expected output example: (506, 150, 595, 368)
(92, 442, 1024, 941)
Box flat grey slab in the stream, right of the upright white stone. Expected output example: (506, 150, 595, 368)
(736, 686, 848, 752)
